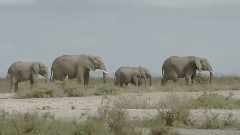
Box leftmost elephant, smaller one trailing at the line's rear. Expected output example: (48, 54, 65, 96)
(8, 61, 48, 92)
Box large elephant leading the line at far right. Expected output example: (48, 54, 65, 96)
(161, 56, 213, 85)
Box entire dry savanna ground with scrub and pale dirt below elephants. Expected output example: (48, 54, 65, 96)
(0, 74, 240, 135)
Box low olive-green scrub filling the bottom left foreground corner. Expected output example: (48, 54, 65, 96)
(0, 111, 106, 135)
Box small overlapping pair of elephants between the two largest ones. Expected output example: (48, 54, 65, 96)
(115, 66, 152, 87)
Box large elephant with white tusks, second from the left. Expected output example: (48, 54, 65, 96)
(51, 55, 108, 85)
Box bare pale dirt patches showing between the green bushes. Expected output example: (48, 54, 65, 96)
(0, 90, 240, 135)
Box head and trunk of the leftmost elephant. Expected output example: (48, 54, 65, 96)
(30, 62, 48, 82)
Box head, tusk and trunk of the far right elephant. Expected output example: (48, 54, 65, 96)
(195, 58, 214, 83)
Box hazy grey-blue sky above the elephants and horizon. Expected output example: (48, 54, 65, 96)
(0, 0, 240, 75)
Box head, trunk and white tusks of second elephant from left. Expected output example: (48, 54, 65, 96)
(88, 56, 108, 83)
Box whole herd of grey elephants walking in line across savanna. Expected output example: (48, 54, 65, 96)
(8, 55, 213, 92)
